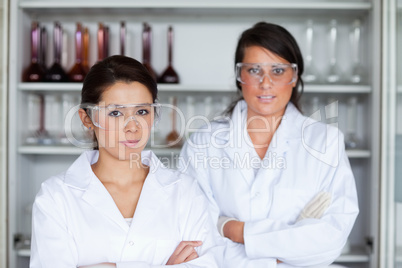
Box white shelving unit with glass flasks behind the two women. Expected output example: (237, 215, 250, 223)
(8, 0, 381, 268)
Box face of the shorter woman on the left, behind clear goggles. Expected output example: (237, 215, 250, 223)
(95, 82, 154, 160)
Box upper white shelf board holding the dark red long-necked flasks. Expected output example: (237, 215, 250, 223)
(18, 83, 371, 93)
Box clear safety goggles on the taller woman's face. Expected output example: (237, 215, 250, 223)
(236, 62, 297, 86)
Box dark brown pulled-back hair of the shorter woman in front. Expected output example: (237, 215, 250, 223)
(81, 55, 158, 149)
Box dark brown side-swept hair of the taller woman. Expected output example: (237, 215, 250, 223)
(226, 22, 304, 115)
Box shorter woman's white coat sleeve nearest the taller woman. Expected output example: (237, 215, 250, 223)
(116, 175, 225, 268)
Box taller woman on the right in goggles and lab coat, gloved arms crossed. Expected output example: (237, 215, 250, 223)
(180, 22, 358, 267)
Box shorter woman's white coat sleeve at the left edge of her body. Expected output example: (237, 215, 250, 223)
(30, 180, 78, 268)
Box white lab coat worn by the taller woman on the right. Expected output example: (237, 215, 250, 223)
(179, 101, 359, 267)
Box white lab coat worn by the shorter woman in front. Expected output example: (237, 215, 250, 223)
(30, 151, 224, 268)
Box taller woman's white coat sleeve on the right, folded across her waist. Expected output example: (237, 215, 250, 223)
(244, 140, 359, 266)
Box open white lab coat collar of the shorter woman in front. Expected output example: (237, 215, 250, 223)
(65, 151, 174, 232)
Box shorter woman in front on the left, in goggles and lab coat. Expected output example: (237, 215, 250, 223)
(30, 56, 224, 268)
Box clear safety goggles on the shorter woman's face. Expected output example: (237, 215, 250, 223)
(81, 103, 161, 131)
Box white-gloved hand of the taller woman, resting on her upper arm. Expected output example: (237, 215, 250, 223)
(297, 192, 332, 221)
